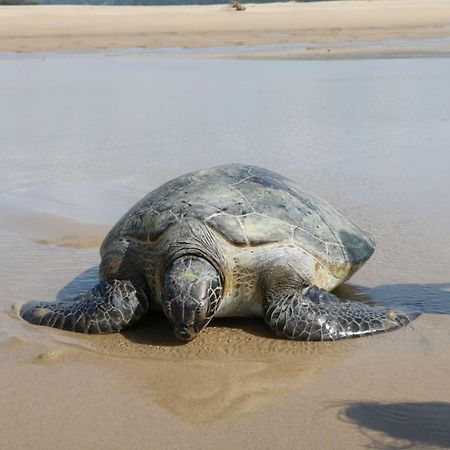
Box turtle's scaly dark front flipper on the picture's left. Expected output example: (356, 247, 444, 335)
(20, 280, 148, 333)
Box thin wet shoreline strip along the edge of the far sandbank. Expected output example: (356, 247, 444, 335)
(0, 38, 450, 61)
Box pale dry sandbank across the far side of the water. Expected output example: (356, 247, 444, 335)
(0, 0, 450, 58)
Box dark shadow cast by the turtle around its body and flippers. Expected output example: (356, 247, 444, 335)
(56, 266, 450, 346)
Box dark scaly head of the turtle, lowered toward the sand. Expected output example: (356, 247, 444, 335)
(162, 256, 222, 341)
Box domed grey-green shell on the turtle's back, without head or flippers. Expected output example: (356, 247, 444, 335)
(107, 164, 374, 277)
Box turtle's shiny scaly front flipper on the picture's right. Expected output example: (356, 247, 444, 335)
(264, 286, 418, 341)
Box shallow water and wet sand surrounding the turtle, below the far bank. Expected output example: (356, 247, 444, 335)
(0, 54, 450, 448)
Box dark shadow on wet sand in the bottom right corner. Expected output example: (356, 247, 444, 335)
(338, 402, 450, 449)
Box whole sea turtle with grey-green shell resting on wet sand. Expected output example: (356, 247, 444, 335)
(20, 164, 414, 341)
